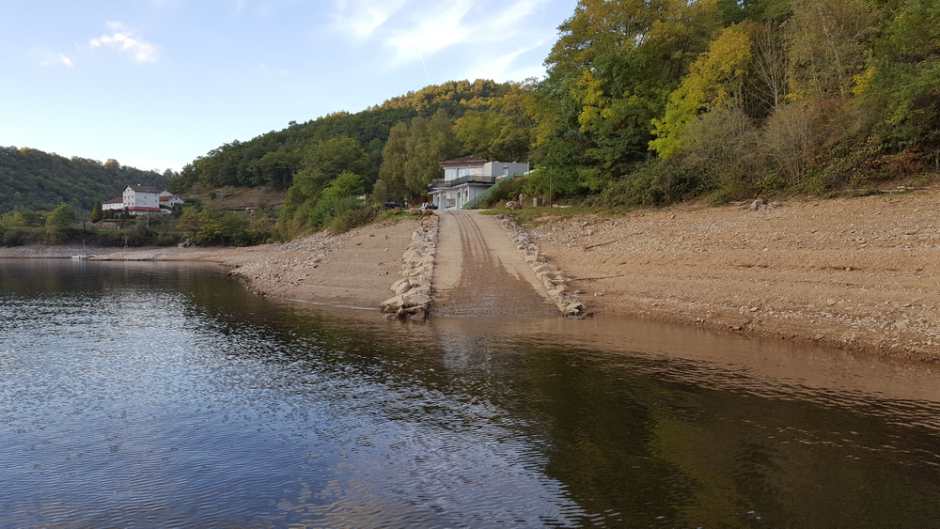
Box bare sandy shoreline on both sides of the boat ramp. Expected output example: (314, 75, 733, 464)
(7, 189, 940, 362)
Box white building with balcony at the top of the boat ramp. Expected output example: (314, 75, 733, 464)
(428, 156, 529, 209)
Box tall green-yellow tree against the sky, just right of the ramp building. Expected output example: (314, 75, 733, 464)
(535, 0, 723, 193)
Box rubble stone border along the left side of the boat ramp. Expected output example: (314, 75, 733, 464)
(382, 215, 438, 321)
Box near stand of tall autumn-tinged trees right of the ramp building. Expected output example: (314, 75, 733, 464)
(533, 0, 940, 205)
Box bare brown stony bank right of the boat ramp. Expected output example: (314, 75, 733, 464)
(527, 189, 940, 362)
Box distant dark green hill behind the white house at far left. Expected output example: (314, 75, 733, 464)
(0, 147, 171, 214)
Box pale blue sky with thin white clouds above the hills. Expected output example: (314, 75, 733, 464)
(0, 0, 577, 172)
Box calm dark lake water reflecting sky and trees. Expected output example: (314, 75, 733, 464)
(0, 261, 940, 527)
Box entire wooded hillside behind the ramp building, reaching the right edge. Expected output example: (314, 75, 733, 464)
(170, 0, 940, 237)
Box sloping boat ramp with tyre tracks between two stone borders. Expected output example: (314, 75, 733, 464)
(431, 211, 558, 316)
